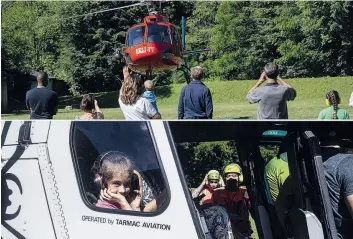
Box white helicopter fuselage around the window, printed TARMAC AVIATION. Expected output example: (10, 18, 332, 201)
(1, 121, 198, 239)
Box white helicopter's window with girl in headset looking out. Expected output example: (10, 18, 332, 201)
(70, 121, 169, 213)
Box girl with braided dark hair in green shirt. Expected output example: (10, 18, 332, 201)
(318, 90, 349, 120)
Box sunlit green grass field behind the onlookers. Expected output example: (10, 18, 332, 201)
(2, 77, 353, 120)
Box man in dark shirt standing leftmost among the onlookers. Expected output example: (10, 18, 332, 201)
(26, 71, 58, 119)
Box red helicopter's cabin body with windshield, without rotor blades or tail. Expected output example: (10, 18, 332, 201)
(123, 12, 184, 79)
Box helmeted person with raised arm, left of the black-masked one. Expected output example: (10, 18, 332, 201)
(192, 170, 224, 204)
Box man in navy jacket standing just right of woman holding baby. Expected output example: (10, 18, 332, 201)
(178, 66, 213, 119)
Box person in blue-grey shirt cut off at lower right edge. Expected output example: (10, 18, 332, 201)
(323, 148, 353, 239)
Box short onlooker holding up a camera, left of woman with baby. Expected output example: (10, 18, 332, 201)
(76, 94, 104, 120)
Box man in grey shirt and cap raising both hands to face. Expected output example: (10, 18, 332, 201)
(246, 63, 297, 119)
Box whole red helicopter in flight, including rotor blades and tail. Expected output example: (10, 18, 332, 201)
(67, 1, 208, 83)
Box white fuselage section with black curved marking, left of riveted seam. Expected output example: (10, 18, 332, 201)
(1, 121, 65, 239)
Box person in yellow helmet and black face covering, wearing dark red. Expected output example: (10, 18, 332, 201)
(212, 163, 252, 238)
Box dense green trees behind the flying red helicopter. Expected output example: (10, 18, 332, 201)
(1, 1, 353, 98)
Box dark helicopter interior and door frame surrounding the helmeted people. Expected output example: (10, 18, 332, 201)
(169, 122, 353, 238)
